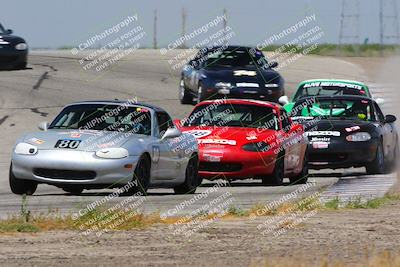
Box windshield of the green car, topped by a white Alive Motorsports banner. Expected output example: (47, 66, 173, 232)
(294, 82, 370, 101)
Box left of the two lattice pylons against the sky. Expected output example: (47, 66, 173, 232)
(336, 0, 360, 55)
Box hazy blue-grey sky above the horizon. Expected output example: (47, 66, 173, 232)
(0, 0, 400, 48)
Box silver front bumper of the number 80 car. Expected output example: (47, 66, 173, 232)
(12, 150, 139, 185)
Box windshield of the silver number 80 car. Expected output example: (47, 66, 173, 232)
(49, 104, 151, 135)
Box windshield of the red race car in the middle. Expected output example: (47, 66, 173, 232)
(184, 104, 278, 130)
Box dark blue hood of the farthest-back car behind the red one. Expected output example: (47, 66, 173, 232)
(203, 67, 280, 84)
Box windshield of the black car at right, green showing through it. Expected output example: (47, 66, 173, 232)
(290, 98, 375, 121)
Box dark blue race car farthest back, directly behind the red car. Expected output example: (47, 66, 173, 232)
(179, 46, 284, 104)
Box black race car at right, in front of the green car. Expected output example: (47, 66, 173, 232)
(290, 95, 399, 174)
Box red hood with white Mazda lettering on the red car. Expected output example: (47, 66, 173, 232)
(180, 126, 277, 149)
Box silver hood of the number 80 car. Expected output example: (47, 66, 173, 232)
(22, 129, 145, 151)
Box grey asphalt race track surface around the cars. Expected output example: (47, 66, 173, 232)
(0, 50, 395, 220)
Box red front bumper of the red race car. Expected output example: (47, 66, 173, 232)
(199, 150, 276, 180)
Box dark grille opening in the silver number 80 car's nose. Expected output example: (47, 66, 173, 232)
(33, 168, 96, 180)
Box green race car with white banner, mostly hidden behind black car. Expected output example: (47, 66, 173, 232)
(279, 79, 384, 115)
